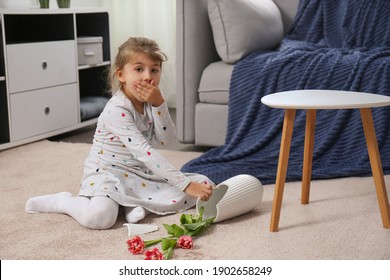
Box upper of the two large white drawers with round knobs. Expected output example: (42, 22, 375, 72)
(7, 40, 77, 93)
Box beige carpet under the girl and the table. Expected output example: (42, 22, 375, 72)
(0, 141, 390, 260)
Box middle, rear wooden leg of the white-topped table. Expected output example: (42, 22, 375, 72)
(301, 110, 317, 204)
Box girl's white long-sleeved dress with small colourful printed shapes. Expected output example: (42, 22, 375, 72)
(79, 91, 213, 214)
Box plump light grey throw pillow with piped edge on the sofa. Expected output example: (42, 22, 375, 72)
(208, 0, 284, 63)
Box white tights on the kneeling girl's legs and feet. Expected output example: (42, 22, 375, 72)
(25, 192, 148, 229)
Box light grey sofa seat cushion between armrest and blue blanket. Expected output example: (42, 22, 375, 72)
(198, 61, 233, 104)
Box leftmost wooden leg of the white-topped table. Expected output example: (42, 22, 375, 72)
(270, 109, 296, 232)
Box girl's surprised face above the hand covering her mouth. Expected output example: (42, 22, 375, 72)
(117, 53, 161, 98)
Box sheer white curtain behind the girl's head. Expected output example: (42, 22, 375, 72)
(101, 0, 176, 107)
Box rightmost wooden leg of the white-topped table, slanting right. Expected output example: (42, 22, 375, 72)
(360, 108, 390, 228)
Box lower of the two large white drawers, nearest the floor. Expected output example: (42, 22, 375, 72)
(10, 84, 79, 141)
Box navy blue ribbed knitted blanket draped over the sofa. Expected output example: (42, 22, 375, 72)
(182, 0, 390, 184)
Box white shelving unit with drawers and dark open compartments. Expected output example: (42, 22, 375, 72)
(0, 9, 111, 150)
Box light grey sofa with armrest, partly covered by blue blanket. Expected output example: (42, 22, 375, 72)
(176, 0, 299, 146)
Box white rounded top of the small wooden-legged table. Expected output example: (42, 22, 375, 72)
(261, 90, 390, 109)
